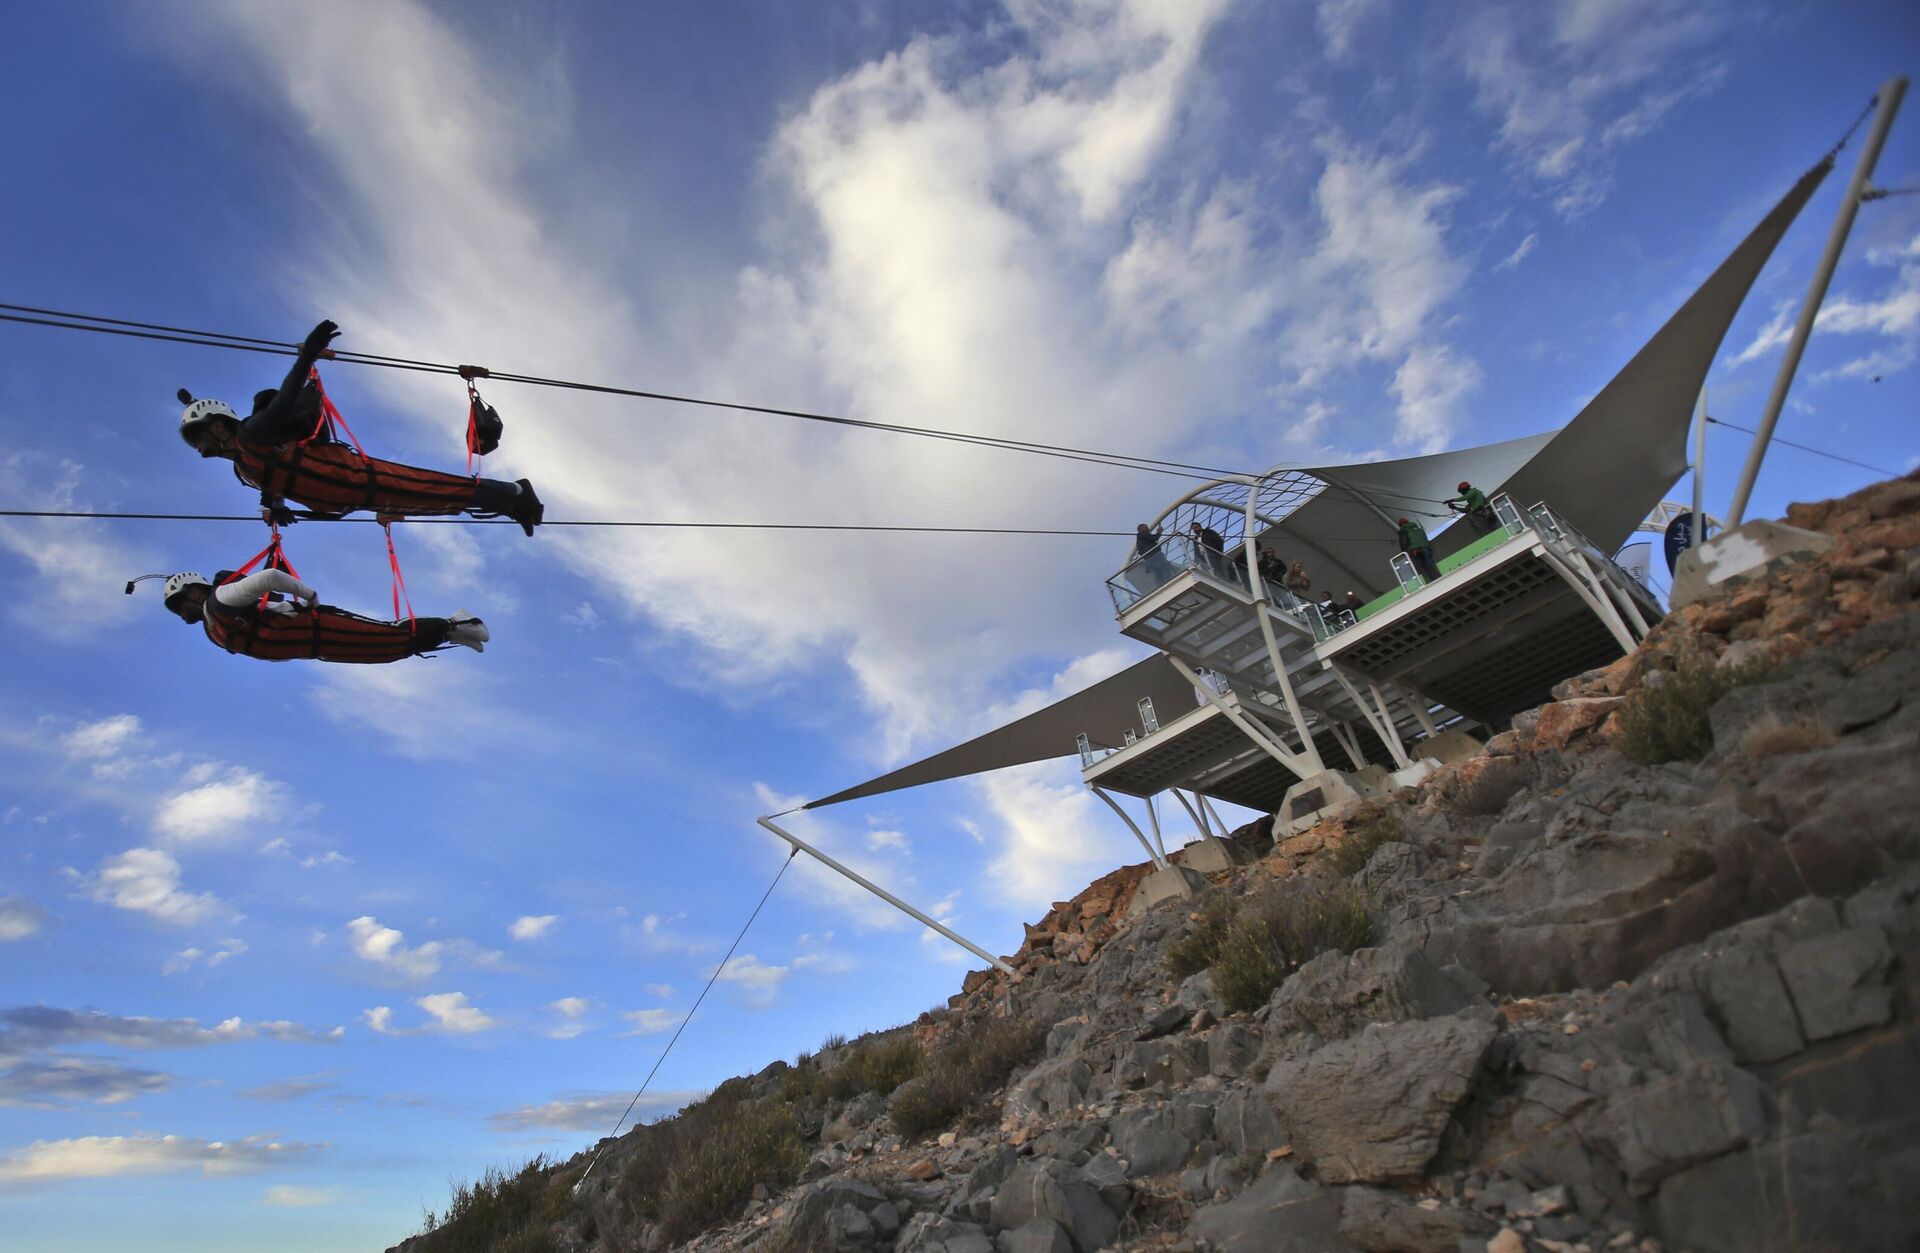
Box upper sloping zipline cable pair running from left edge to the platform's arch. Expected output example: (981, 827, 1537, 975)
(0, 303, 1238, 478)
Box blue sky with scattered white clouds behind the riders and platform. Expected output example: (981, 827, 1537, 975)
(0, 0, 1920, 1249)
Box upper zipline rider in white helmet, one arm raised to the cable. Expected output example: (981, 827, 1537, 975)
(179, 322, 545, 535)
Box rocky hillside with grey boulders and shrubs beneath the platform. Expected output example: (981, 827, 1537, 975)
(403, 476, 1920, 1253)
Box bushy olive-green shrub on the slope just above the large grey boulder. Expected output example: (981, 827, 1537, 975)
(1213, 879, 1373, 1009)
